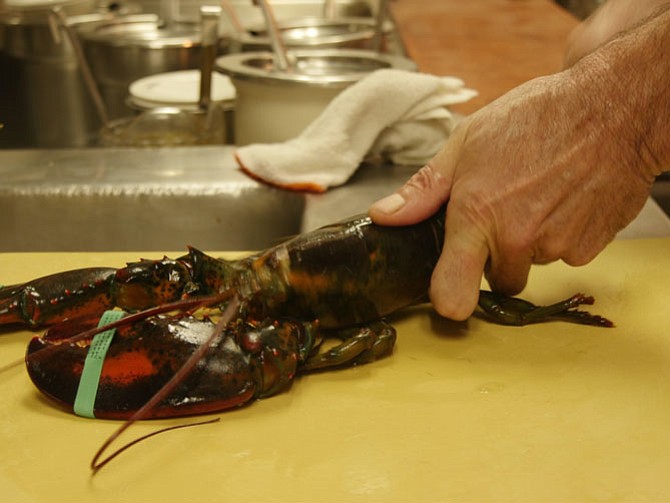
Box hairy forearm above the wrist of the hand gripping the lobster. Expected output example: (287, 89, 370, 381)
(566, 3, 670, 179)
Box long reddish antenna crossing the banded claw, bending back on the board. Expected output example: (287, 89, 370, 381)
(91, 294, 241, 475)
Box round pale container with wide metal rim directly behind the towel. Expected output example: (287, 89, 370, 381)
(216, 49, 416, 145)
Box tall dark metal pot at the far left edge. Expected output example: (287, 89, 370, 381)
(0, 0, 106, 148)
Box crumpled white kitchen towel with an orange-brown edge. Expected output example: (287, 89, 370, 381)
(235, 69, 477, 192)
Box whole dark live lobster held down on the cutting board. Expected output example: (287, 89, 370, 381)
(0, 208, 611, 424)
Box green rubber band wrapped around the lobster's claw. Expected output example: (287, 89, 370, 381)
(74, 311, 126, 418)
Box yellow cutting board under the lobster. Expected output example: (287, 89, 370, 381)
(0, 239, 670, 502)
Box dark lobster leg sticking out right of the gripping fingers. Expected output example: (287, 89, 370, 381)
(479, 290, 614, 327)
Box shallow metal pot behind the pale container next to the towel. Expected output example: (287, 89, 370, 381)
(231, 17, 392, 51)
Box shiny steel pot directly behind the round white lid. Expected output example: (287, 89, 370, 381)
(79, 16, 231, 119)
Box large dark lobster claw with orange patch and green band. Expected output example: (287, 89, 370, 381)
(26, 317, 262, 419)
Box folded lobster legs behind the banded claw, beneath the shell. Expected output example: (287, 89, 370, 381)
(300, 320, 396, 372)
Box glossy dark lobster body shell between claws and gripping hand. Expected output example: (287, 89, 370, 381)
(242, 212, 444, 328)
